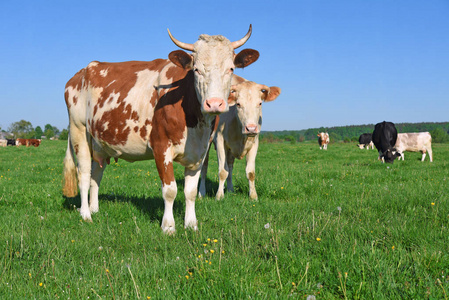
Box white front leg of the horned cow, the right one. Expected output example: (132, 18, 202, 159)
(184, 168, 201, 230)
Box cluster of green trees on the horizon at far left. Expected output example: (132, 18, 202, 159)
(0, 120, 69, 140)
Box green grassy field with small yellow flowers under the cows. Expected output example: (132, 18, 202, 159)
(0, 141, 449, 299)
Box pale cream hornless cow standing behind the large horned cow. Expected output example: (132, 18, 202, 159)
(199, 76, 281, 200)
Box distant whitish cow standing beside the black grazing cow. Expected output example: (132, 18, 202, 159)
(395, 132, 433, 162)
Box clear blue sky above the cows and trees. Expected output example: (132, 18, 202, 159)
(0, 0, 449, 130)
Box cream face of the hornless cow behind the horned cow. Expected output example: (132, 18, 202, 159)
(228, 81, 281, 136)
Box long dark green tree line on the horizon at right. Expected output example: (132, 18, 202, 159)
(260, 122, 449, 143)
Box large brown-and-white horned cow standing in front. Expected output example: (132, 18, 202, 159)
(64, 26, 259, 234)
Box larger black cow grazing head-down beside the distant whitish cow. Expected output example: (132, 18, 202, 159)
(373, 121, 401, 163)
